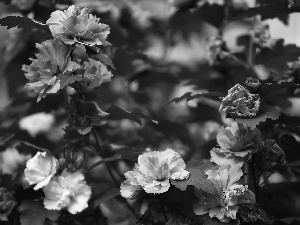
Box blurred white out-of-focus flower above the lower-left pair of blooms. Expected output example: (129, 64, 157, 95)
(19, 112, 55, 137)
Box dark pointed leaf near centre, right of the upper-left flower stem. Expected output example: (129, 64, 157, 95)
(106, 105, 158, 125)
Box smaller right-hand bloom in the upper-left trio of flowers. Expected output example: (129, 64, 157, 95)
(80, 58, 112, 92)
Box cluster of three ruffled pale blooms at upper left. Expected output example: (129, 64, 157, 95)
(22, 6, 112, 101)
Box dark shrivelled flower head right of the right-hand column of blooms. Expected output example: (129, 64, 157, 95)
(254, 139, 285, 172)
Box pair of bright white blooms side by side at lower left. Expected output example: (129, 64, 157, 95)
(24, 152, 92, 214)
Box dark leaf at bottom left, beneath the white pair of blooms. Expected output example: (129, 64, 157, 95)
(19, 200, 59, 225)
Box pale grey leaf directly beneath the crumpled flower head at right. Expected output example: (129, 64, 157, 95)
(235, 111, 280, 130)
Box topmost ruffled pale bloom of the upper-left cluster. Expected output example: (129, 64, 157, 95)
(46, 5, 110, 46)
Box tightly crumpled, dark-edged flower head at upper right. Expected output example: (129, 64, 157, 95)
(219, 84, 260, 118)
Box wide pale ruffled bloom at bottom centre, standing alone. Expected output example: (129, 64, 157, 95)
(121, 149, 190, 198)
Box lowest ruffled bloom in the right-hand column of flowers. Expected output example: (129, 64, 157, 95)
(194, 166, 255, 223)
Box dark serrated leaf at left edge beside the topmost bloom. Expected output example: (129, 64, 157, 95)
(0, 16, 51, 33)
